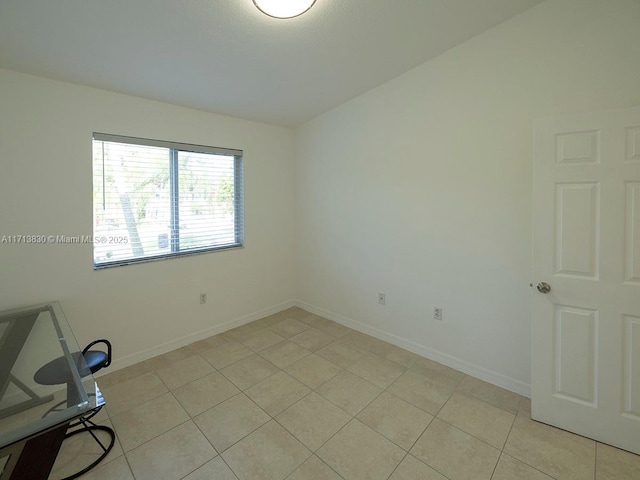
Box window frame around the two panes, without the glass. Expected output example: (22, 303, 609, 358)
(91, 132, 244, 270)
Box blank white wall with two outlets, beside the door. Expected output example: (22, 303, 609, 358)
(296, 0, 640, 394)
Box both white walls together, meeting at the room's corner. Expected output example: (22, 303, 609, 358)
(0, 0, 640, 393)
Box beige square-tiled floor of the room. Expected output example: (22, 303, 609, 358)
(51, 308, 640, 480)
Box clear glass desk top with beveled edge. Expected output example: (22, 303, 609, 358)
(0, 302, 104, 449)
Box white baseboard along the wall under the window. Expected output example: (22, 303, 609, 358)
(95, 300, 296, 378)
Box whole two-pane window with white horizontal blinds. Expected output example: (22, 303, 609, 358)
(93, 133, 244, 268)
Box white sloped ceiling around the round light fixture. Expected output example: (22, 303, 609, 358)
(0, 0, 542, 127)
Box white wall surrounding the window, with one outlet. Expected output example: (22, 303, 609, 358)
(0, 70, 295, 367)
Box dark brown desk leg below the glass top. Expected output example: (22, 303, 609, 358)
(5, 423, 69, 480)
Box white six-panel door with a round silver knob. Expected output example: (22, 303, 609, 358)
(531, 107, 640, 453)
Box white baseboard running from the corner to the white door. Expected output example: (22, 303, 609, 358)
(296, 300, 531, 397)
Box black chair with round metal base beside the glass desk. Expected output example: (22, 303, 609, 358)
(33, 339, 116, 480)
